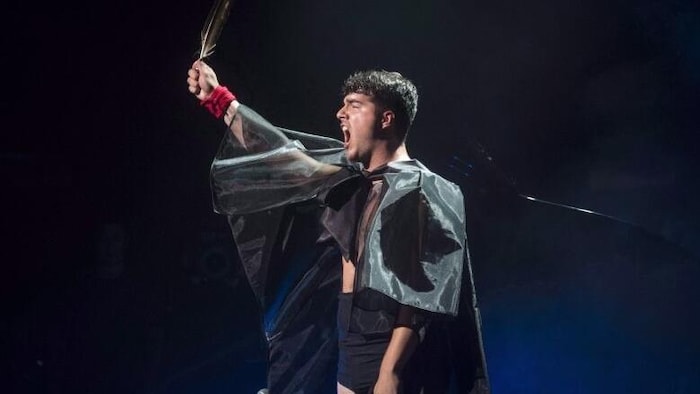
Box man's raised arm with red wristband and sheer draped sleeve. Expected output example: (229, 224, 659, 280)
(187, 60, 343, 215)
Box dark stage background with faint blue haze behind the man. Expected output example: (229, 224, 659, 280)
(6, 0, 700, 393)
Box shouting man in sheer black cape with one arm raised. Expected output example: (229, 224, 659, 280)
(187, 61, 485, 394)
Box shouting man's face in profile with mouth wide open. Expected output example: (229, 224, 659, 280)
(335, 93, 381, 166)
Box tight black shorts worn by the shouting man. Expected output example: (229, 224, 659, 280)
(338, 293, 392, 394)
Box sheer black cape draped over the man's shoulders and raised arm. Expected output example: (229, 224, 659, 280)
(211, 105, 489, 393)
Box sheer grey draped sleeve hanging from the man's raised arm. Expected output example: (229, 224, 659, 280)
(210, 105, 350, 215)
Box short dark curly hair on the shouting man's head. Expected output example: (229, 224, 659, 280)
(342, 70, 418, 139)
